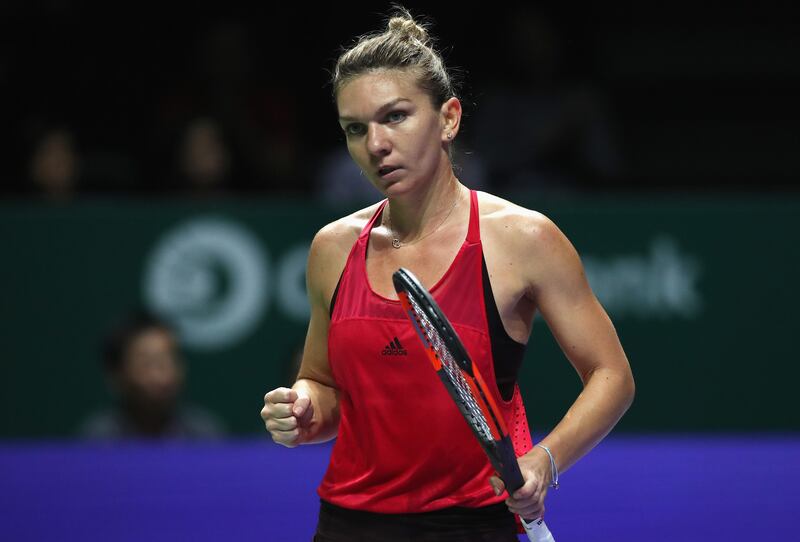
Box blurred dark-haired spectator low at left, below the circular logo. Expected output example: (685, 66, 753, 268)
(80, 311, 224, 439)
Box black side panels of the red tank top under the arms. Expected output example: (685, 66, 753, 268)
(329, 251, 525, 401)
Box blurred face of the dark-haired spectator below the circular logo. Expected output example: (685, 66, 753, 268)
(120, 328, 183, 408)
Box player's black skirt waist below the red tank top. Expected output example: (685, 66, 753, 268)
(313, 499, 519, 542)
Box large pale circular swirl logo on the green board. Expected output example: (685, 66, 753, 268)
(144, 217, 269, 350)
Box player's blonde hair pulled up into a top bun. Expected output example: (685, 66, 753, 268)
(330, 4, 456, 108)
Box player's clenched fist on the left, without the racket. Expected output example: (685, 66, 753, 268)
(261, 388, 314, 448)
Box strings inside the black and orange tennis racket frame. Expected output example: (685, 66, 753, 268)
(408, 296, 494, 442)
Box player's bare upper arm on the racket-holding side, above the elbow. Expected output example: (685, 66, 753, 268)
(525, 213, 630, 384)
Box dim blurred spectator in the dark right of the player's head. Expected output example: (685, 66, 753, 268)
(468, 5, 620, 197)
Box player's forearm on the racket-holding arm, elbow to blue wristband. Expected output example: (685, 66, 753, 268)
(534, 368, 635, 473)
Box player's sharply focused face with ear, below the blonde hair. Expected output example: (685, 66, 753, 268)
(336, 70, 460, 195)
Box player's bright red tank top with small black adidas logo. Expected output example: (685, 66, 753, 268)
(318, 191, 532, 513)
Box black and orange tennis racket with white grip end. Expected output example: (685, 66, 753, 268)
(392, 267, 555, 542)
